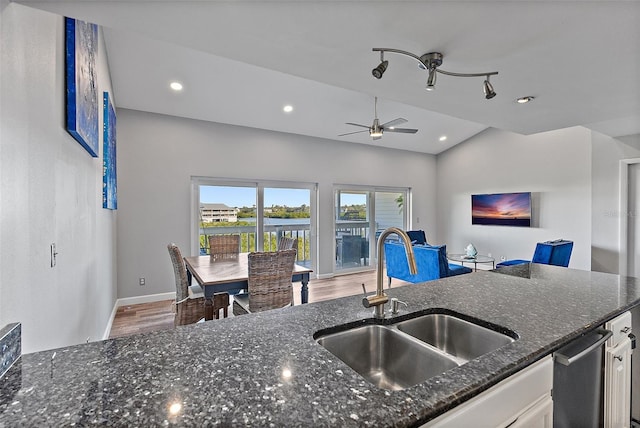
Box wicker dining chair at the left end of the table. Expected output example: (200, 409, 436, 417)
(167, 243, 204, 326)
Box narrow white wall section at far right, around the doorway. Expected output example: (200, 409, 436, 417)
(591, 132, 640, 273)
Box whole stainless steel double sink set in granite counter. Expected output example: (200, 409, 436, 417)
(314, 313, 517, 390)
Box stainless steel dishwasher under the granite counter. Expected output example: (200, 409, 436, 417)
(553, 329, 613, 428)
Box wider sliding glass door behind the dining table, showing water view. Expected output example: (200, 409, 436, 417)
(192, 177, 316, 269)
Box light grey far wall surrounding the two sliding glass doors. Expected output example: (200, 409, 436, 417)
(117, 109, 435, 298)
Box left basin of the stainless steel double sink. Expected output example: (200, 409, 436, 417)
(317, 325, 458, 390)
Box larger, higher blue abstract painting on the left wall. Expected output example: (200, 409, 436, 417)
(65, 17, 100, 157)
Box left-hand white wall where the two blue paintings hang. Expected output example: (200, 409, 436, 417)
(0, 1, 116, 353)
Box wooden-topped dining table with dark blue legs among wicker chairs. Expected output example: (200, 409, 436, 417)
(184, 253, 313, 320)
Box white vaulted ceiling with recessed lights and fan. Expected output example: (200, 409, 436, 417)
(19, 0, 640, 154)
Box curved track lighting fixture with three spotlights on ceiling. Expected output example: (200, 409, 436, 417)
(372, 48, 498, 100)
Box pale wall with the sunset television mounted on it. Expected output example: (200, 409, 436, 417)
(437, 127, 591, 270)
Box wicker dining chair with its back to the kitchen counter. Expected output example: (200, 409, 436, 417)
(233, 249, 297, 315)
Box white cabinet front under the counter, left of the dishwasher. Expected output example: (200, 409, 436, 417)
(423, 356, 553, 428)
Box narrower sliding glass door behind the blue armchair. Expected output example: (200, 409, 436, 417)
(334, 186, 409, 272)
